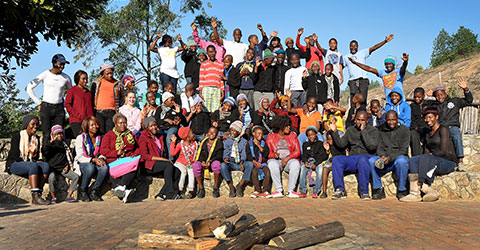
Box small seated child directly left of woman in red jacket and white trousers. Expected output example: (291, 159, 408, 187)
(246, 126, 272, 198)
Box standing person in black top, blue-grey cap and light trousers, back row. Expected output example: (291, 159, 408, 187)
(250, 49, 275, 110)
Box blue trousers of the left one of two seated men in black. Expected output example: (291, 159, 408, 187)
(332, 155, 371, 194)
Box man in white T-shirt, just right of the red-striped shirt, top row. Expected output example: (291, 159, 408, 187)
(212, 20, 248, 65)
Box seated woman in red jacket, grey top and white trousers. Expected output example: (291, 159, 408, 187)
(267, 115, 300, 198)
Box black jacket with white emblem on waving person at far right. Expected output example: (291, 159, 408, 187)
(434, 91, 473, 127)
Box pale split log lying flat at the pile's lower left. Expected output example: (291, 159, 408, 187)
(138, 233, 196, 249)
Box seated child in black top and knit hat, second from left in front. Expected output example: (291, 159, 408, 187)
(42, 125, 80, 203)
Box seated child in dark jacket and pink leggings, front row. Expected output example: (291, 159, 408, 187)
(193, 127, 223, 198)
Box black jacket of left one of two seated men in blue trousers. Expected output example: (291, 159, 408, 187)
(329, 125, 378, 155)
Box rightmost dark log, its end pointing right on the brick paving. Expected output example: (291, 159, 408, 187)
(268, 221, 345, 249)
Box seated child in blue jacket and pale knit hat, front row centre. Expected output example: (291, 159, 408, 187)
(221, 120, 253, 198)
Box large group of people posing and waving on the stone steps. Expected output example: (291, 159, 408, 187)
(6, 19, 473, 204)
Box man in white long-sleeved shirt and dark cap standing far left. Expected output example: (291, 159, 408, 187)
(25, 54, 72, 143)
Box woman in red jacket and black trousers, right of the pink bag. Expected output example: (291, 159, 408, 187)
(139, 117, 184, 200)
